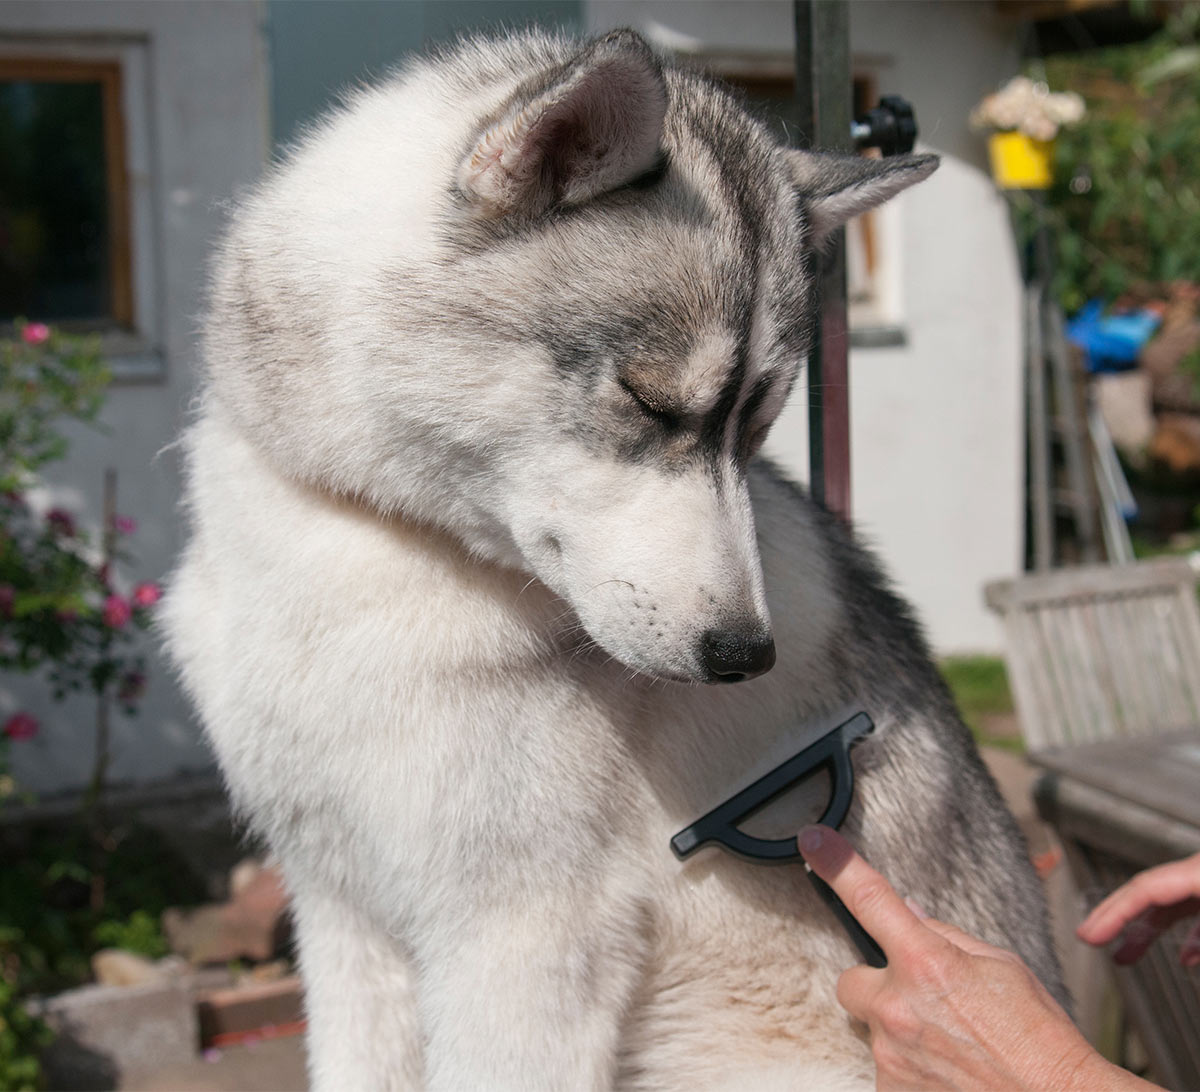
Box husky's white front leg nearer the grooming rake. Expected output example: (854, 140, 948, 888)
(420, 877, 643, 1092)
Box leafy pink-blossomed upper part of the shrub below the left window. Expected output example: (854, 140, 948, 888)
(0, 323, 160, 797)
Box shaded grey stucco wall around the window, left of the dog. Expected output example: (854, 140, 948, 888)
(0, 0, 266, 791)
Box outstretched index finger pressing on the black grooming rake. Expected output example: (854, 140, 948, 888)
(798, 827, 930, 958)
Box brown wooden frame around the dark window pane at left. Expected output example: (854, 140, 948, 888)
(0, 56, 133, 330)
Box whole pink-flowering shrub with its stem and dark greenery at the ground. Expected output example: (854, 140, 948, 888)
(0, 323, 171, 1090)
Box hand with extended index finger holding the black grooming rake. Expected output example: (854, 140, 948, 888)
(799, 827, 1152, 1092)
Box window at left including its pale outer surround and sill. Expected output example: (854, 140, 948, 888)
(0, 34, 166, 382)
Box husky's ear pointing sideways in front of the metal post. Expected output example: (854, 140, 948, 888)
(786, 150, 941, 242)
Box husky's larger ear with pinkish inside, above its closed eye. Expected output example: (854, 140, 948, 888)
(457, 30, 667, 217)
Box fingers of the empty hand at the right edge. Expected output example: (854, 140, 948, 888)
(1075, 853, 1200, 967)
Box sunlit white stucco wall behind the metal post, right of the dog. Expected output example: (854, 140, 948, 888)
(584, 0, 1022, 652)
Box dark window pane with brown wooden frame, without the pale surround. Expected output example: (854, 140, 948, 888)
(0, 58, 133, 330)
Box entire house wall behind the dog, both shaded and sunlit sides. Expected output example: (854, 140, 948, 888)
(0, 0, 1020, 792)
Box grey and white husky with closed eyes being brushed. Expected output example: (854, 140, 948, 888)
(166, 31, 1061, 1092)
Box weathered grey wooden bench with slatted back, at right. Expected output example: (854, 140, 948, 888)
(985, 559, 1200, 1088)
